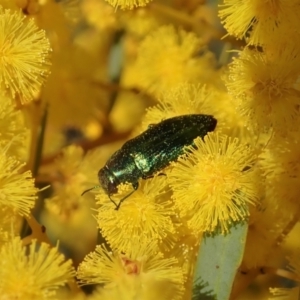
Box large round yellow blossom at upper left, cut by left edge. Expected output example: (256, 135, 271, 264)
(0, 7, 51, 103)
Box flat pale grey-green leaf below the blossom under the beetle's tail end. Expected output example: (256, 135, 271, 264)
(192, 222, 248, 300)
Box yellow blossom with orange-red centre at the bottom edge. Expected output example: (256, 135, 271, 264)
(77, 244, 184, 300)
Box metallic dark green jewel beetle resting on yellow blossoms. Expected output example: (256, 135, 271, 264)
(82, 114, 217, 210)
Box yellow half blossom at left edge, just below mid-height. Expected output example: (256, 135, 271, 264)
(0, 147, 38, 215)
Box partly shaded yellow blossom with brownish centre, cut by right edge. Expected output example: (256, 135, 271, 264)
(226, 47, 300, 132)
